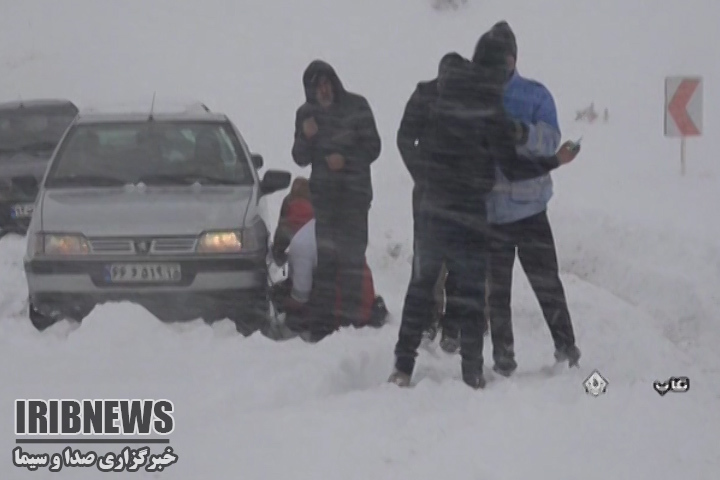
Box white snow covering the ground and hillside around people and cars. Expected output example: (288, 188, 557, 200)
(0, 0, 720, 480)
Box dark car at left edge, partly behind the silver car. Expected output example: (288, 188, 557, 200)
(0, 99, 78, 235)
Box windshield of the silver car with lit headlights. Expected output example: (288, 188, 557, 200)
(45, 121, 254, 188)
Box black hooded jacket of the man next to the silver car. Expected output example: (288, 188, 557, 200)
(292, 60, 381, 208)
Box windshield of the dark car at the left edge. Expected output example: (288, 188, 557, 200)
(0, 105, 77, 157)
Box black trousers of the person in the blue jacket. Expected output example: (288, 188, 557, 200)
(488, 212, 575, 359)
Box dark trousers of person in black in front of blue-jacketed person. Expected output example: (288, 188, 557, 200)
(395, 214, 487, 377)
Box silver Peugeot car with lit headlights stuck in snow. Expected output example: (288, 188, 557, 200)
(24, 104, 291, 335)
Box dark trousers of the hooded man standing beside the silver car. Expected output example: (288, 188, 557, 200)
(313, 201, 369, 331)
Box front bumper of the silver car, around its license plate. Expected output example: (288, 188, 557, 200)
(24, 257, 267, 301)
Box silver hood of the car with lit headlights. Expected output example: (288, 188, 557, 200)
(40, 186, 255, 237)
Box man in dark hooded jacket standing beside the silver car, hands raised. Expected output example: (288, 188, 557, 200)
(292, 60, 381, 334)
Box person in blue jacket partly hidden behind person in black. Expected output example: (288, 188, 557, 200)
(476, 21, 580, 376)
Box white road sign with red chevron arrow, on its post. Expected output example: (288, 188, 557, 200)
(665, 77, 703, 175)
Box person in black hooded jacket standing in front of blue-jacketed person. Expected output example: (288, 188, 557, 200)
(388, 33, 577, 388)
